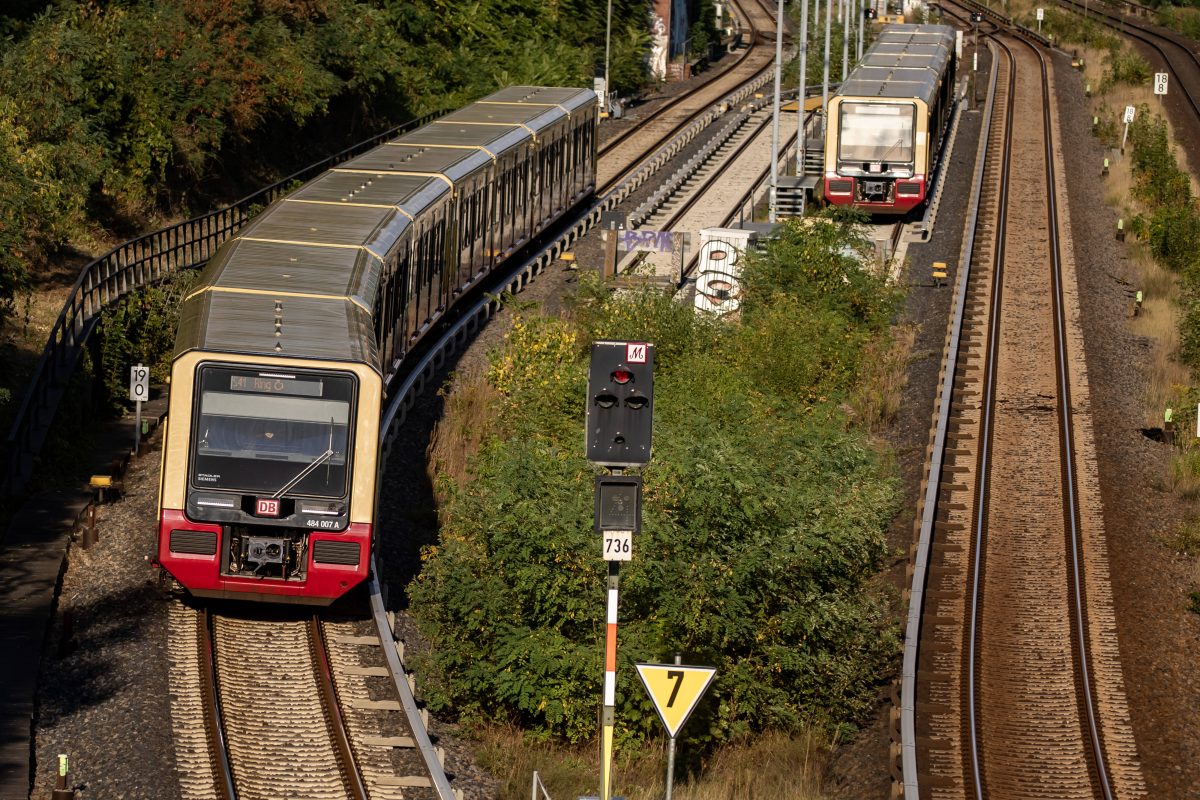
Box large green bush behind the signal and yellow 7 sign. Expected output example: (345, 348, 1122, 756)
(409, 217, 898, 742)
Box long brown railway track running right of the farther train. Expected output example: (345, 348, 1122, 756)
(896, 10, 1145, 800)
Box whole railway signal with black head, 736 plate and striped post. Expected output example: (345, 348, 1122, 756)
(584, 342, 654, 800)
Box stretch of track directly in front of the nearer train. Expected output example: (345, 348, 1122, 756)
(170, 592, 455, 800)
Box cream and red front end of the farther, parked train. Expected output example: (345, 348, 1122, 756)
(824, 97, 930, 213)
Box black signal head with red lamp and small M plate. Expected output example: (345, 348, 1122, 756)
(586, 342, 654, 467)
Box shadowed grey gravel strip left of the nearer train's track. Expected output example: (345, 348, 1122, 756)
(32, 437, 176, 800)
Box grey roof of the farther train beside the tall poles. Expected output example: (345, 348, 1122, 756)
(838, 25, 955, 103)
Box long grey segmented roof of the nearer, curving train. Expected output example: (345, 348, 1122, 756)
(175, 86, 596, 369)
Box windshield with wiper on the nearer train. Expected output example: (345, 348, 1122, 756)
(192, 366, 354, 498)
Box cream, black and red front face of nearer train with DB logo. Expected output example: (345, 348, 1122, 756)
(157, 351, 382, 604)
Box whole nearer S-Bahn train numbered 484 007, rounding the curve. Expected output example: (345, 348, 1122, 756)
(156, 86, 598, 604)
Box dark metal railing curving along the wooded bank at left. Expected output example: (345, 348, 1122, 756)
(0, 112, 445, 499)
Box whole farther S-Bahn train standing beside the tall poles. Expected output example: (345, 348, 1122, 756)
(823, 25, 959, 213)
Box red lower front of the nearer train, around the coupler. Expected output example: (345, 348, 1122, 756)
(158, 509, 371, 604)
